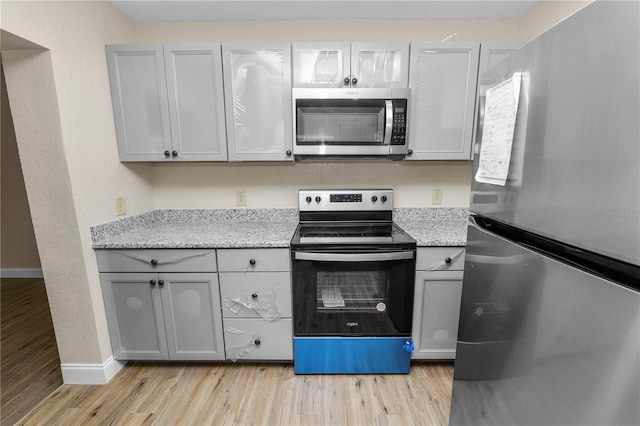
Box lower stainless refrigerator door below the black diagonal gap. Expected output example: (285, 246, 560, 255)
(449, 222, 640, 426)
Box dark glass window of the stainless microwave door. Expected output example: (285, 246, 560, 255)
(296, 99, 386, 145)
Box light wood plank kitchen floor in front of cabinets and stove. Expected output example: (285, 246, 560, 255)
(20, 363, 453, 425)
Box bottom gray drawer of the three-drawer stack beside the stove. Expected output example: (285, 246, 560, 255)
(224, 318, 293, 361)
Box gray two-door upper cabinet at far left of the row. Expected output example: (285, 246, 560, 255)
(106, 45, 227, 161)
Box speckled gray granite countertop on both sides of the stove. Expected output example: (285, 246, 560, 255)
(90, 208, 468, 249)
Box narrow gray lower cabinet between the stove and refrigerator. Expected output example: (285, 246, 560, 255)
(412, 247, 464, 359)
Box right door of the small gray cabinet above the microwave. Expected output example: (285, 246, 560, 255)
(351, 43, 409, 88)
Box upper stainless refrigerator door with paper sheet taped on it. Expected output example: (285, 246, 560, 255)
(470, 1, 640, 265)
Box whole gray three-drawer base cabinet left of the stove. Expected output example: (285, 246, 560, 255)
(218, 248, 293, 361)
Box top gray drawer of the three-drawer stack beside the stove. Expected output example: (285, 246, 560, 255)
(218, 248, 291, 272)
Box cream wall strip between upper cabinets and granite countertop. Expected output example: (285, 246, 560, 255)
(153, 161, 471, 209)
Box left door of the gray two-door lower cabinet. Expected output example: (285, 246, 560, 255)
(100, 273, 168, 360)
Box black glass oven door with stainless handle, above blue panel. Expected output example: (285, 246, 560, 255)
(292, 250, 415, 337)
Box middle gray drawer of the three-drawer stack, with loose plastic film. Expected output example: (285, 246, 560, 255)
(220, 272, 291, 319)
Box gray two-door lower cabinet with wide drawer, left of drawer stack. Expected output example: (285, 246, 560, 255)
(97, 250, 225, 361)
